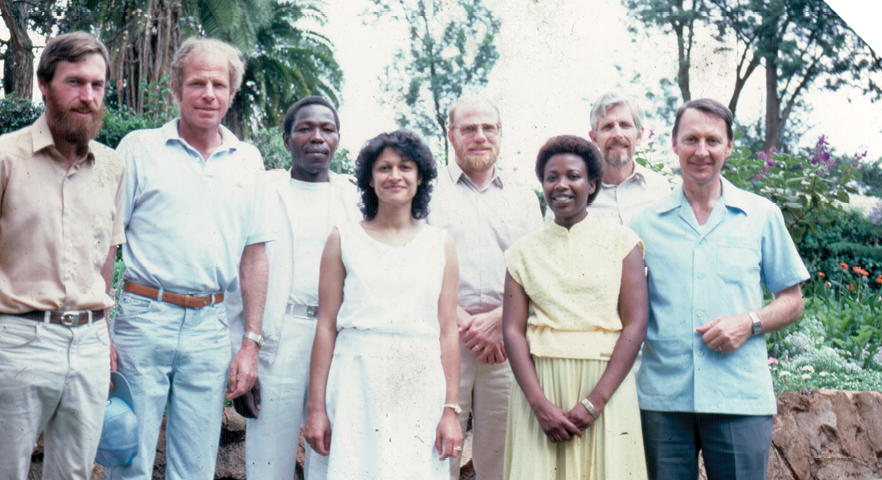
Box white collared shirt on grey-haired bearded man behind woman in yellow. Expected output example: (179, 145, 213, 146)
(592, 162, 671, 225)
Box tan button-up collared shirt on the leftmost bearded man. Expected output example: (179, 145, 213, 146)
(0, 113, 125, 314)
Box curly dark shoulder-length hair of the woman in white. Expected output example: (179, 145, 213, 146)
(355, 130, 438, 220)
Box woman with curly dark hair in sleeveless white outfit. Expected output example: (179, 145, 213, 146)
(305, 130, 463, 480)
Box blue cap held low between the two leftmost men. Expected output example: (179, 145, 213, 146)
(95, 372, 138, 467)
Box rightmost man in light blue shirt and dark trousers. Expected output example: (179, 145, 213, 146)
(629, 99, 809, 480)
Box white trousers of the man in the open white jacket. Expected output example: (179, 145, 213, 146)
(245, 315, 316, 480)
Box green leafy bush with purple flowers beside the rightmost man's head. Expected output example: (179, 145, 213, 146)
(722, 136, 859, 244)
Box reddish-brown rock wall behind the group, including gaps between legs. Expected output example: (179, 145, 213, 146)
(28, 390, 882, 480)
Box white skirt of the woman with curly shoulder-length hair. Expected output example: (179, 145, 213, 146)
(306, 329, 449, 480)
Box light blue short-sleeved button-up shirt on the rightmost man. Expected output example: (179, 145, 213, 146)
(629, 179, 809, 415)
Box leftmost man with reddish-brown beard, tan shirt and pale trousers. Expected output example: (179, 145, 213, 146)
(0, 32, 125, 480)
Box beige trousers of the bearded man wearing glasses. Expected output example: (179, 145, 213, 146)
(450, 340, 514, 480)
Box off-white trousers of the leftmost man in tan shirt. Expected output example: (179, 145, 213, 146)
(0, 315, 110, 480)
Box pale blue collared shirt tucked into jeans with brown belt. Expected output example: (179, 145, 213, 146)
(117, 119, 275, 295)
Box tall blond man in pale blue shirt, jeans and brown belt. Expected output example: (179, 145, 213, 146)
(107, 39, 274, 480)
